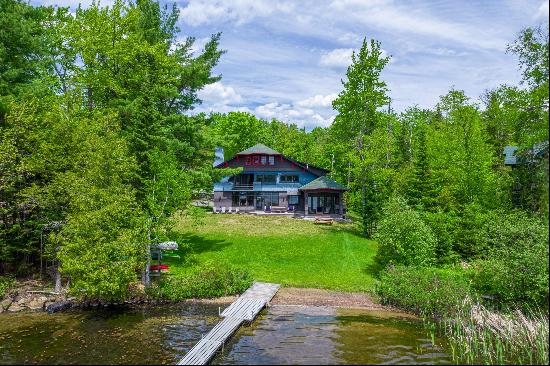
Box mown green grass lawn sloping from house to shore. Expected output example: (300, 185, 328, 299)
(166, 214, 376, 291)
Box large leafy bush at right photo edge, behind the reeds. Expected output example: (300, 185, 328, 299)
(474, 212, 549, 308)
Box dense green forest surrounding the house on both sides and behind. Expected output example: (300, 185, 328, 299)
(0, 0, 549, 320)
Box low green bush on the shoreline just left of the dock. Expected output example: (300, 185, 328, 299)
(147, 265, 252, 301)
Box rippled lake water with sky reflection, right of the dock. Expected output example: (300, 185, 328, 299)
(213, 306, 451, 364)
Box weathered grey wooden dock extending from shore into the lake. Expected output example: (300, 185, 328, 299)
(178, 282, 280, 365)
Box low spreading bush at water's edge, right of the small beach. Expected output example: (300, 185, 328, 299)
(376, 266, 475, 317)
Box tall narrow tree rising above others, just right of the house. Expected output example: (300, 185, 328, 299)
(332, 38, 389, 236)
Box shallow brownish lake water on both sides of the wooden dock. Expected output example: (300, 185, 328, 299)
(0, 304, 450, 364)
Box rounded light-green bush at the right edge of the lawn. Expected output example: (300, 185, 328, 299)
(375, 197, 436, 268)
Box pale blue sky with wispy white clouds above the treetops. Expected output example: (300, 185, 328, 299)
(31, 0, 548, 130)
